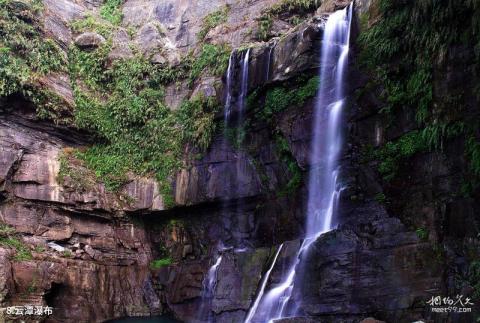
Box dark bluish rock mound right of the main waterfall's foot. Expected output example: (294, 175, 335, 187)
(296, 203, 443, 322)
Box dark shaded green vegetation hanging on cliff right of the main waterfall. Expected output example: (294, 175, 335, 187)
(359, 0, 480, 191)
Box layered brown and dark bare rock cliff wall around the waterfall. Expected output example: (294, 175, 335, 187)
(0, 1, 479, 322)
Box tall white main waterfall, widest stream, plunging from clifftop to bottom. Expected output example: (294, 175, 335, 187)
(245, 4, 353, 323)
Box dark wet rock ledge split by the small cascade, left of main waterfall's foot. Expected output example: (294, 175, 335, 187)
(157, 248, 271, 322)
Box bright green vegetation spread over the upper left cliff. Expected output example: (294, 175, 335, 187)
(0, 0, 230, 205)
